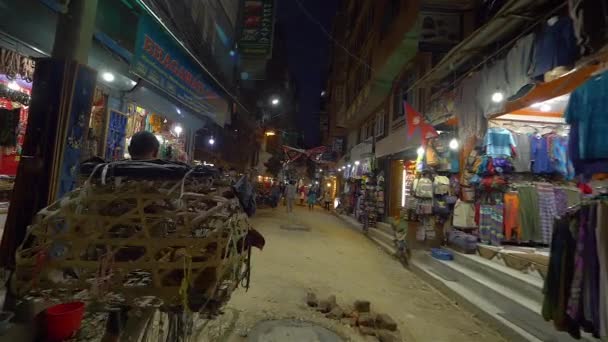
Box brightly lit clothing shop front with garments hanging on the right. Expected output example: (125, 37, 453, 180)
(422, 16, 608, 338)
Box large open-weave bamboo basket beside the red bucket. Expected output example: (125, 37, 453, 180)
(12, 162, 250, 313)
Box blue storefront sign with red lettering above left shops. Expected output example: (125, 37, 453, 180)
(131, 16, 219, 117)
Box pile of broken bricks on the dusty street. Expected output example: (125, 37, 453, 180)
(306, 292, 402, 342)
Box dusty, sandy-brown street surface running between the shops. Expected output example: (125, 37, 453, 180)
(199, 207, 504, 342)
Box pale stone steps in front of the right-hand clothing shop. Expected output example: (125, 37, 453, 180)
(410, 251, 588, 342)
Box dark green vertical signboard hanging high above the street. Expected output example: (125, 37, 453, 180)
(239, 0, 274, 57)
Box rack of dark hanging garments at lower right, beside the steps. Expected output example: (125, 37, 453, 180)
(542, 200, 608, 338)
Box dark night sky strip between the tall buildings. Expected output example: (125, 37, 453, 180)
(277, 0, 337, 147)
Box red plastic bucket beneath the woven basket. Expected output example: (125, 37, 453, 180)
(46, 302, 84, 342)
